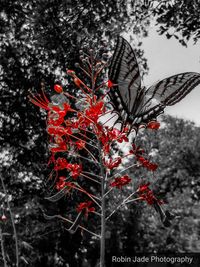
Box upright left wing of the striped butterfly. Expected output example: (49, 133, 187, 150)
(108, 36, 144, 124)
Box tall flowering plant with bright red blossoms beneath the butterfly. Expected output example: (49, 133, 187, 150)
(30, 43, 172, 267)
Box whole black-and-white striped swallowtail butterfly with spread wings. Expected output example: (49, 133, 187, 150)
(108, 36, 200, 130)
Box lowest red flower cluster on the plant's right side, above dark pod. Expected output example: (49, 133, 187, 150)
(137, 183, 163, 205)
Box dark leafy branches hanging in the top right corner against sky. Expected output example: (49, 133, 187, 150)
(152, 0, 200, 46)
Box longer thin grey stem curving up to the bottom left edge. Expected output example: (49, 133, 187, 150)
(0, 175, 19, 267)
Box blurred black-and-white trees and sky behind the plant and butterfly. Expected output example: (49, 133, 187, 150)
(0, 0, 200, 267)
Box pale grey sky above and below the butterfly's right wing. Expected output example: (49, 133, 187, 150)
(142, 26, 200, 126)
